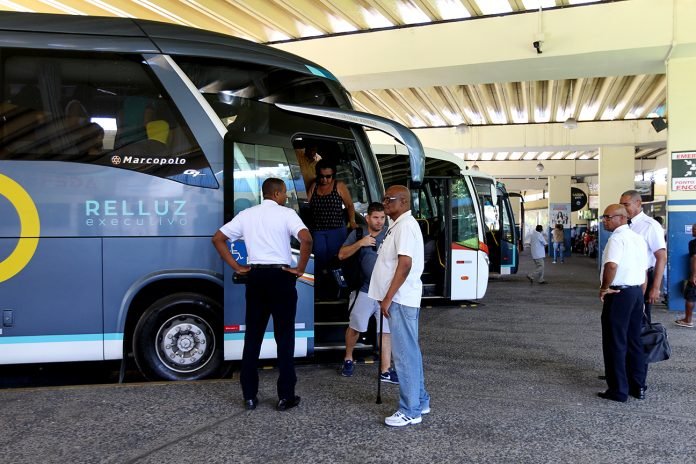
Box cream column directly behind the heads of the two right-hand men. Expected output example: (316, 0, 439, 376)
(597, 147, 635, 261)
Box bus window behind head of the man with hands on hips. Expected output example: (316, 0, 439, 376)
(233, 143, 299, 215)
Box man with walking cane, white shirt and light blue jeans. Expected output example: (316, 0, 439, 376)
(368, 185, 430, 427)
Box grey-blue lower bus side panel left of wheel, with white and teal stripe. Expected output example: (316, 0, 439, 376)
(0, 237, 104, 364)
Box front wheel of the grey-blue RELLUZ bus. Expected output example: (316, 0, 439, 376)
(133, 293, 223, 380)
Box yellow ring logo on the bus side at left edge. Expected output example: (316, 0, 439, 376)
(0, 174, 41, 282)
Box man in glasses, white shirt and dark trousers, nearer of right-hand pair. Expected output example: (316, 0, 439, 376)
(597, 204, 648, 403)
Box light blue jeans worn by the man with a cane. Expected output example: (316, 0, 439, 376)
(389, 302, 430, 417)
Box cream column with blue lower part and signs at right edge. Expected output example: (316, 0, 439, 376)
(665, 53, 696, 311)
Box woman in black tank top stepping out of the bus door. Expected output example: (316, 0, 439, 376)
(307, 160, 357, 287)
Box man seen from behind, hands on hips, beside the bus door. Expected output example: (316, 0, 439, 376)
(213, 178, 312, 411)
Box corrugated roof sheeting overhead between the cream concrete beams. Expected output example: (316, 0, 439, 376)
(0, 0, 666, 160)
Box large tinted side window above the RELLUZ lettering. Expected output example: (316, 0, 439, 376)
(0, 50, 218, 188)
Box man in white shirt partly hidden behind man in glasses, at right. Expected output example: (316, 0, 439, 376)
(619, 190, 667, 324)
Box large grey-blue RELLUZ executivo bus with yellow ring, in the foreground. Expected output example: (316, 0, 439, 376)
(0, 13, 424, 379)
